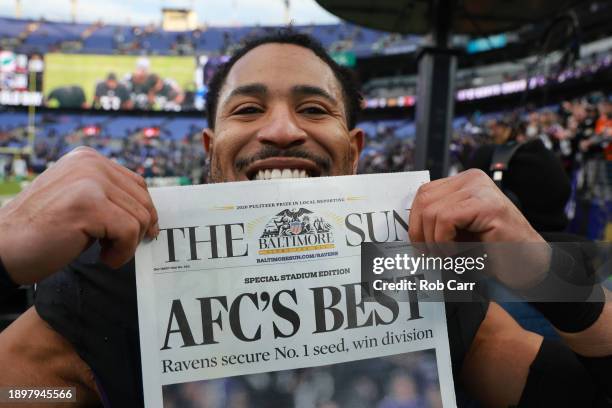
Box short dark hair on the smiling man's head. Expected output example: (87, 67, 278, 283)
(206, 28, 362, 129)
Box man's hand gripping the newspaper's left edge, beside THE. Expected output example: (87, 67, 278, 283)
(0, 147, 159, 284)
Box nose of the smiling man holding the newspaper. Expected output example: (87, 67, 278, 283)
(257, 108, 307, 148)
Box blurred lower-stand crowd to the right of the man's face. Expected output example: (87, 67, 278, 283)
(360, 94, 612, 200)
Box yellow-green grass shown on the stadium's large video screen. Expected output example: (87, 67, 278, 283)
(43, 54, 196, 103)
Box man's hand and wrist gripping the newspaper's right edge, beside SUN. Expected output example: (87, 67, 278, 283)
(409, 169, 550, 289)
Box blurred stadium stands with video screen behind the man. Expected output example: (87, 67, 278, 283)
(0, 1, 612, 242)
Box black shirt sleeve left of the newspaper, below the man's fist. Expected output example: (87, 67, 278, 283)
(35, 245, 143, 407)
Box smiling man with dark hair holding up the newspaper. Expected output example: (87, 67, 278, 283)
(0, 32, 612, 407)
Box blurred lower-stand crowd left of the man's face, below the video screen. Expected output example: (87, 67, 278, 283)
(0, 113, 206, 183)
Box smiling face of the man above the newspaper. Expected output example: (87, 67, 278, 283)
(204, 44, 363, 182)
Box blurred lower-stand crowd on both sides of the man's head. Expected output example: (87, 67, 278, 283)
(0, 90, 612, 236)
